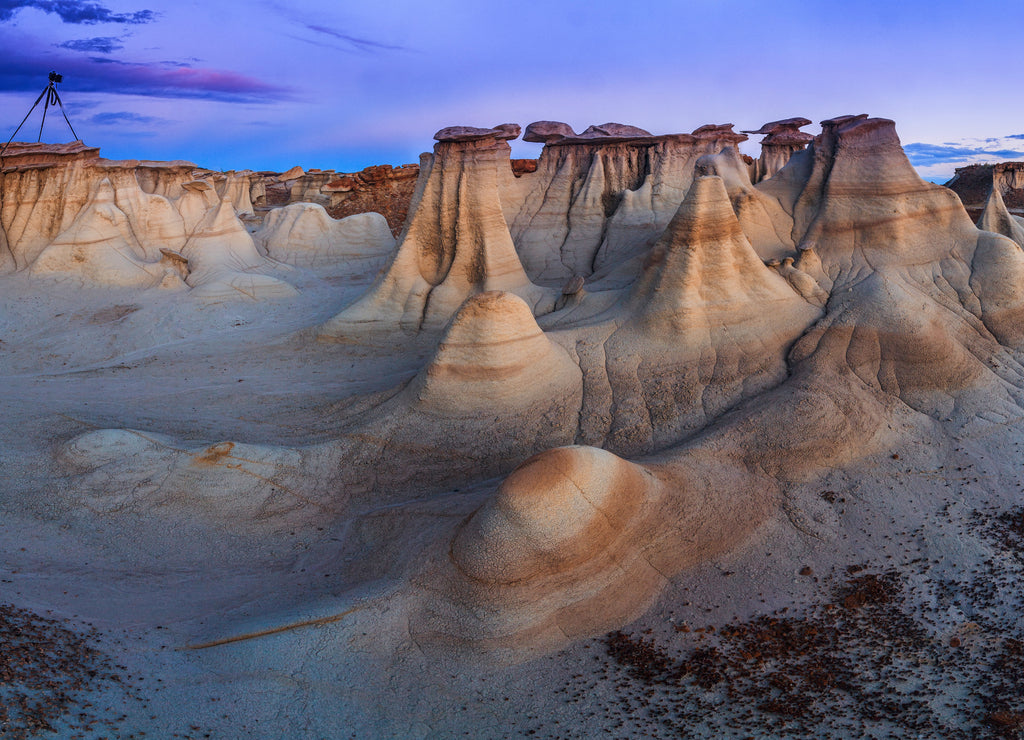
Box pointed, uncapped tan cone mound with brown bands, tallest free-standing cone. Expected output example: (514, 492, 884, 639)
(585, 176, 820, 454)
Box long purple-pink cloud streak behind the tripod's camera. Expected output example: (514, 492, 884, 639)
(0, 44, 290, 102)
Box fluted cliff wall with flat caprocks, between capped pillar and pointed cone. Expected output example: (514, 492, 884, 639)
(502, 121, 746, 282)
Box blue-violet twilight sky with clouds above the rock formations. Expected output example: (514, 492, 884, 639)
(0, 0, 1024, 181)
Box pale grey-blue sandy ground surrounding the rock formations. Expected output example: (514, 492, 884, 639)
(0, 270, 1024, 738)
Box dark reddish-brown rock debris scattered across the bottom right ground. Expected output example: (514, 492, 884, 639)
(534, 564, 1024, 740)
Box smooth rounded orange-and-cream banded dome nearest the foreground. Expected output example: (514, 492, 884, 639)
(452, 446, 651, 583)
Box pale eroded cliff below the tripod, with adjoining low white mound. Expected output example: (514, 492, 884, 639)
(0, 142, 393, 300)
